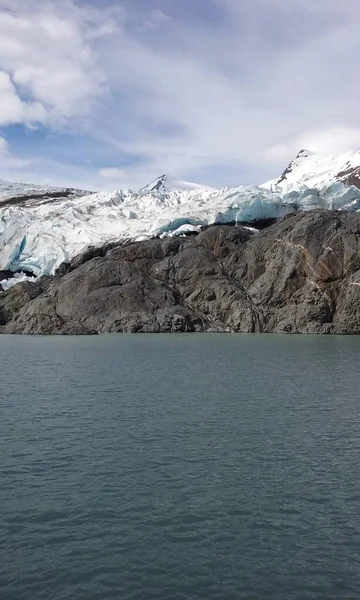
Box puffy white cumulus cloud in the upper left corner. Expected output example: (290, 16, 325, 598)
(0, 0, 106, 125)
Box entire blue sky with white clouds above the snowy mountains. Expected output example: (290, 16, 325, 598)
(0, 0, 360, 190)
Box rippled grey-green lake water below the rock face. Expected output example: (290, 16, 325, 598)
(0, 334, 360, 600)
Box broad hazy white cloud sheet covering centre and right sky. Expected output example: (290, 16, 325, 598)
(88, 0, 360, 184)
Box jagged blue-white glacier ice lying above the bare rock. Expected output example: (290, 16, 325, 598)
(0, 153, 360, 288)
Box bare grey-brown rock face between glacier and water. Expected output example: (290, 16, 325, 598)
(0, 211, 360, 334)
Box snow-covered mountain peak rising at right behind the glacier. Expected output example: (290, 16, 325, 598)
(262, 150, 360, 192)
